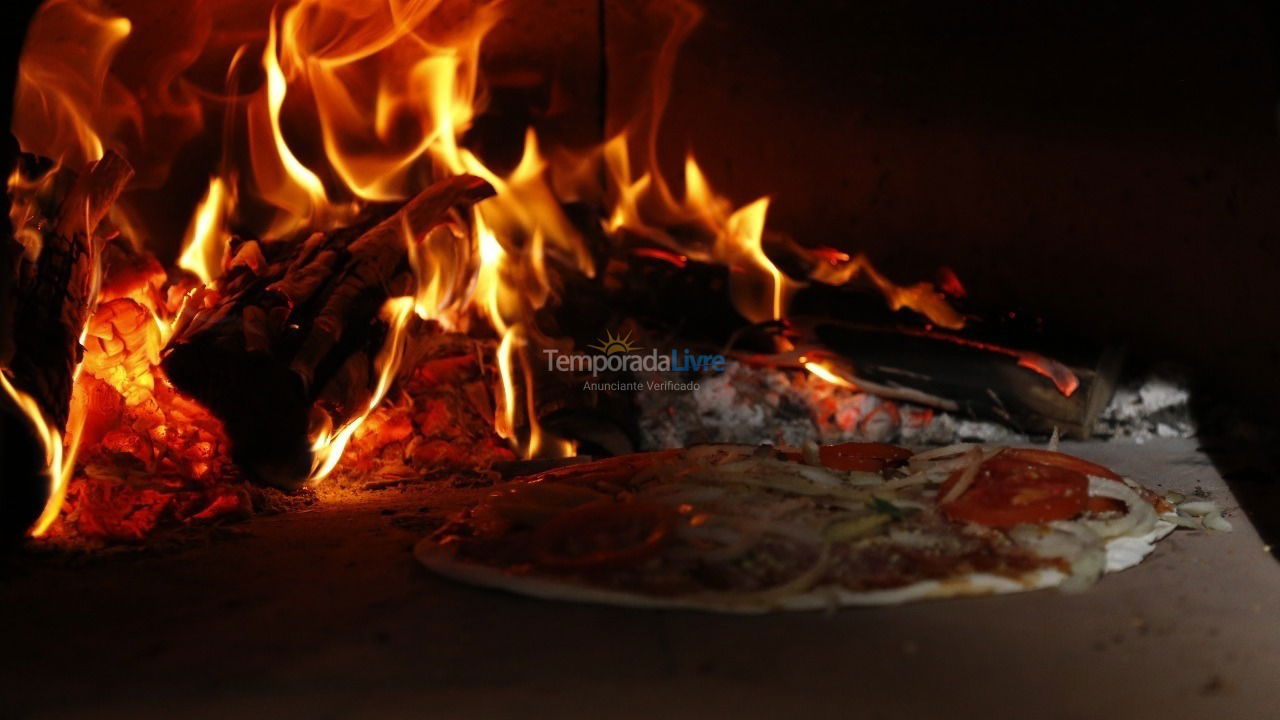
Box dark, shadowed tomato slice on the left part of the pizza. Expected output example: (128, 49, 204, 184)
(532, 501, 675, 570)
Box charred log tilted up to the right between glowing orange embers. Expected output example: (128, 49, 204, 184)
(163, 176, 493, 488)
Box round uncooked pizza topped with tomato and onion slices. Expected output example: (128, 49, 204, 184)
(416, 443, 1178, 612)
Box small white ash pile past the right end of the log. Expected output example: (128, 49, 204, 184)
(1096, 370, 1196, 442)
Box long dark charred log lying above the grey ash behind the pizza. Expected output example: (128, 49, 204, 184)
(553, 233, 1120, 437)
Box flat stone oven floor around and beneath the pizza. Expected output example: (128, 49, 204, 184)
(0, 441, 1280, 720)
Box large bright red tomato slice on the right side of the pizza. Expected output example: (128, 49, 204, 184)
(938, 454, 1089, 528)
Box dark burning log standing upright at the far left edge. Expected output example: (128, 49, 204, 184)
(0, 152, 133, 537)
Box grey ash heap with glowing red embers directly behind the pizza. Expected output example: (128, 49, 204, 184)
(637, 361, 1027, 450)
